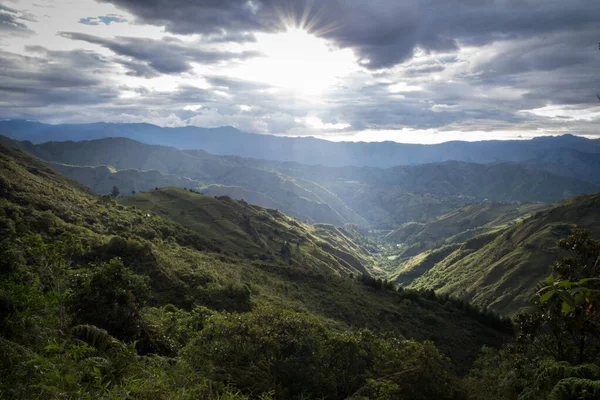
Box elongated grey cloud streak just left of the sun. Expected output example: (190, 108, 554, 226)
(61, 32, 259, 76)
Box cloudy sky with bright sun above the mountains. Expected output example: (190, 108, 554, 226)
(0, 0, 600, 143)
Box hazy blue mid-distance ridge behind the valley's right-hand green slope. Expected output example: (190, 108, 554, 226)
(253, 159, 598, 229)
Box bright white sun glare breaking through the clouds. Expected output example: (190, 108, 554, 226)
(226, 27, 357, 97)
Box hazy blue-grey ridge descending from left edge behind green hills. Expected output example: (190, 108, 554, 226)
(0, 136, 367, 225)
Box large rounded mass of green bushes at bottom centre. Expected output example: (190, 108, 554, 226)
(183, 307, 453, 399)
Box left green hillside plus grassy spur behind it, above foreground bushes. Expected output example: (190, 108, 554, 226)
(0, 143, 507, 382)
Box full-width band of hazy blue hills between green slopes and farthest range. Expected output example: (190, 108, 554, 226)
(4, 138, 598, 230)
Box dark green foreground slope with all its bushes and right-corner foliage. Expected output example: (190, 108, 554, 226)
(0, 139, 600, 400)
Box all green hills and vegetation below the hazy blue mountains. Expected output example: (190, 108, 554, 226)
(0, 134, 600, 400)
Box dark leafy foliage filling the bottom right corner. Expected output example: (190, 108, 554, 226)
(467, 230, 600, 400)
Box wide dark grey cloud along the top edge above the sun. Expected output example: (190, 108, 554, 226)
(102, 0, 600, 69)
